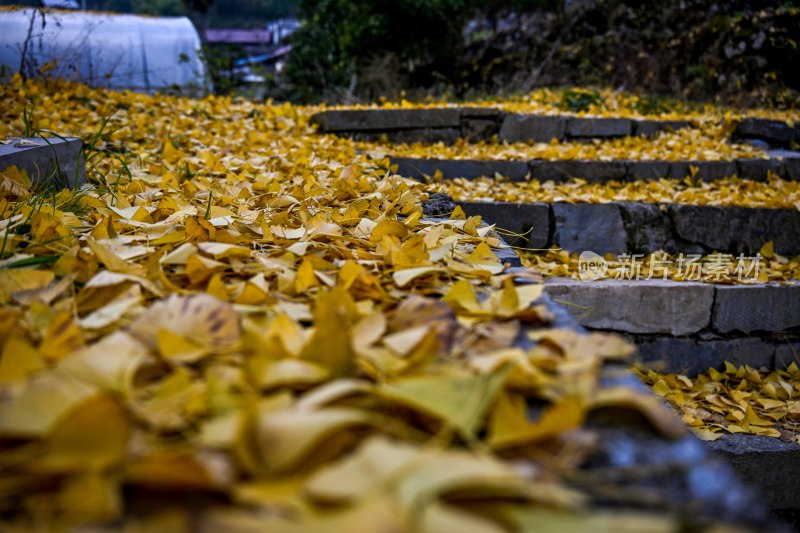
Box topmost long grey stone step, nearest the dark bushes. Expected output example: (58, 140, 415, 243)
(311, 107, 692, 143)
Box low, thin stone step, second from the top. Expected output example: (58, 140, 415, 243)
(390, 154, 800, 183)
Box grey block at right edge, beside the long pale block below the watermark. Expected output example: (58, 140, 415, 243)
(712, 283, 800, 333)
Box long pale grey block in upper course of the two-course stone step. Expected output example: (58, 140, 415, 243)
(545, 278, 714, 335)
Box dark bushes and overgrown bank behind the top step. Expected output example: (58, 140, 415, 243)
(276, 0, 800, 105)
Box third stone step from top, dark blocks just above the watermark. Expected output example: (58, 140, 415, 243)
(458, 201, 800, 256)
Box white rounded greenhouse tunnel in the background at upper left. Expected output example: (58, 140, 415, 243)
(0, 9, 205, 92)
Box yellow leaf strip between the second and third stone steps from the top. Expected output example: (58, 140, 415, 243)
(431, 175, 800, 209)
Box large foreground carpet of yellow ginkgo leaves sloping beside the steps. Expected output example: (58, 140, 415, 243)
(0, 78, 700, 532)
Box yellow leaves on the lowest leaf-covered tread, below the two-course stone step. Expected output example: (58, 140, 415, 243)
(637, 362, 800, 444)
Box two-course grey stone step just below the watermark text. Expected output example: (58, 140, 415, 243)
(545, 278, 800, 376)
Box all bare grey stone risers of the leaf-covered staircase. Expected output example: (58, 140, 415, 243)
(313, 108, 800, 525)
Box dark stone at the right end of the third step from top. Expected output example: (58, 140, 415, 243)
(669, 205, 800, 255)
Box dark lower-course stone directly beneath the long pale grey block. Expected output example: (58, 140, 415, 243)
(636, 337, 775, 376)
